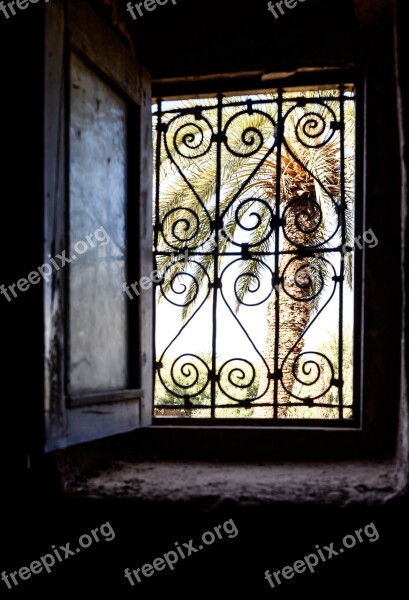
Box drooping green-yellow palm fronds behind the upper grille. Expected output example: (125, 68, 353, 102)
(155, 91, 355, 320)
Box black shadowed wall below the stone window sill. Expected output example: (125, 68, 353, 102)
(0, 499, 409, 600)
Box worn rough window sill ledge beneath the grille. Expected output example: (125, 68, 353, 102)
(62, 460, 404, 507)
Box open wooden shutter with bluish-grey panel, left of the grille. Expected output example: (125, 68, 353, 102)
(44, 0, 153, 451)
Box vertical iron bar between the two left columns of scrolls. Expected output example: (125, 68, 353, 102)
(210, 94, 223, 418)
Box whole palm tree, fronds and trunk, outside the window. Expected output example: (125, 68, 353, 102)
(156, 91, 354, 417)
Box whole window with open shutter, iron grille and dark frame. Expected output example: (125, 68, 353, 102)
(43, 0, 402, 468)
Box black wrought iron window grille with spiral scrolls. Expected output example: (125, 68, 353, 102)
(154, 84, 356, 424)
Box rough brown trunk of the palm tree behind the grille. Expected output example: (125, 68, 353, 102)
(247, 106, 353, 417)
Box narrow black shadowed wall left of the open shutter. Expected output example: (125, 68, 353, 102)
(0, 5, 44, 483)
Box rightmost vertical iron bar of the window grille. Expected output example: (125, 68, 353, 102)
(338, 84, 346, 419)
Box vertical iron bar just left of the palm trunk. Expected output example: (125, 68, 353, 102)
(273, 88, 284, 419)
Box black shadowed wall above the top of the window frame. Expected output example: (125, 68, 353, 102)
(94, 0, 360, 80)
